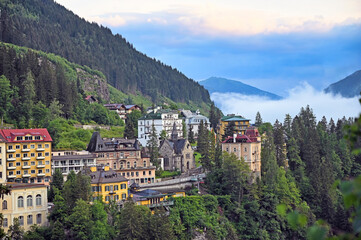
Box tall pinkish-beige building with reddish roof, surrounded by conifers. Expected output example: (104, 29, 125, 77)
(222, 127, 261, 177)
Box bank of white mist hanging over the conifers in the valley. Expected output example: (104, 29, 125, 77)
(211, 83, 361, 124)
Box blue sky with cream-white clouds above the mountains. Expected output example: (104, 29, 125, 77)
(56, 0, 361, 122)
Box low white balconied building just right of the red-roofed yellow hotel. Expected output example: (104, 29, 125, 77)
(51, 151, 97, 181)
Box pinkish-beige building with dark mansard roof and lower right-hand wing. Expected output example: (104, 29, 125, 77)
(87, 132, 155, 185)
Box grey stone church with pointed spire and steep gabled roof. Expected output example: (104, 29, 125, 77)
(159, 125, 195, 173)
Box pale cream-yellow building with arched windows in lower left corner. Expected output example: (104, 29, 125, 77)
(0, 183, 48, 232)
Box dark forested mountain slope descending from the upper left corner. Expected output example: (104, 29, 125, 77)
(0, 0, 210, 104)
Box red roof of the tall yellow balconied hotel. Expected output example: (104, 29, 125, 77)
(0, 128, 53, 142)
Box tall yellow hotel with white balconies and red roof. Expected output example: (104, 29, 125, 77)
(0, 128, 53, 184)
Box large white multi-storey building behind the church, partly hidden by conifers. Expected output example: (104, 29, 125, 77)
(138, 110, 183, 146)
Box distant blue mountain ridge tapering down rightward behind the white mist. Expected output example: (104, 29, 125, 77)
(198, 77, 282, 100)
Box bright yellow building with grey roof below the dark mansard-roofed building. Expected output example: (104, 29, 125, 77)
(87, 166, 128, 203)
